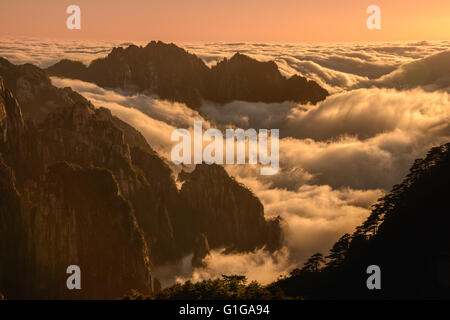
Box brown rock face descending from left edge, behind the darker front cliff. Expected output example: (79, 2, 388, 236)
(0, 59, 180, 264)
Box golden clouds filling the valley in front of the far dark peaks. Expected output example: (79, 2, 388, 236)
(52, 74, 450, 283)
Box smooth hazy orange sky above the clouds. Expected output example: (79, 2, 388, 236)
(0, 0, 450, 42)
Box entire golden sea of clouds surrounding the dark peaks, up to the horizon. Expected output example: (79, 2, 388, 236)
(0, 39, 450, 285)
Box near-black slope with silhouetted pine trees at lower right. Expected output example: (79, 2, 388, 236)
(274, 143, 450, 299)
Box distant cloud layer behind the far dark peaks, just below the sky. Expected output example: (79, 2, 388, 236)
(0, 37, 450, 93)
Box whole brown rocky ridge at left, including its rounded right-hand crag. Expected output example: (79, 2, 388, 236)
(0, 58, 281, 299)
